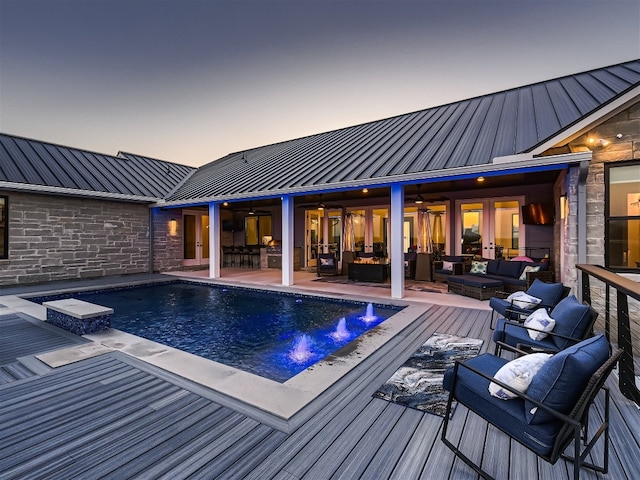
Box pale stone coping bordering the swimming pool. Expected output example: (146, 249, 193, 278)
(4, 278, 433, 432)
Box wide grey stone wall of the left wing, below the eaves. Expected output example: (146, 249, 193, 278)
(0, 192, 150, 286)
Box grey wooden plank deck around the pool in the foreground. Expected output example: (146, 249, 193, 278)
(0, 290, 640, 480)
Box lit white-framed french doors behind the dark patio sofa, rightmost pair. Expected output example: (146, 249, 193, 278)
(456, 196, 525, 259)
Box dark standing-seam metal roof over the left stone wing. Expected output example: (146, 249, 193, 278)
(0, 134, 196, 202)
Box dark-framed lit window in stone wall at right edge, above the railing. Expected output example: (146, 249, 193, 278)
(605, 162, 640, 270)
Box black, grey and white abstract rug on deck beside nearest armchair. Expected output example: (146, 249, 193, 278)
(373, 332, 483, 417)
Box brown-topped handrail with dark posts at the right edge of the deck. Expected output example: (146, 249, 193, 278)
(576, 264, 640, 405)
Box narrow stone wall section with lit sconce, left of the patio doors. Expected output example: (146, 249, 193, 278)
(152, 208, 184, 272)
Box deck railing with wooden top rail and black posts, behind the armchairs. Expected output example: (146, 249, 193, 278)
(576, 264, 640, 405)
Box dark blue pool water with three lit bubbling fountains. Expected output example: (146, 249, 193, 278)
(42, 282, 401, 382)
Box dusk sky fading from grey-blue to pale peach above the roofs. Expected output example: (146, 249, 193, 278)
(0, 0, 640, 166)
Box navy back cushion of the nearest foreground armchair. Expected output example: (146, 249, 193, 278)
(524, 334, 609, 425)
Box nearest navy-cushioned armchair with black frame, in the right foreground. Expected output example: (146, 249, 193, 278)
(441, 335, 621, 480)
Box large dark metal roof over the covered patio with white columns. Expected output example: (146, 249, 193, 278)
(167, 60, 640, 204)
